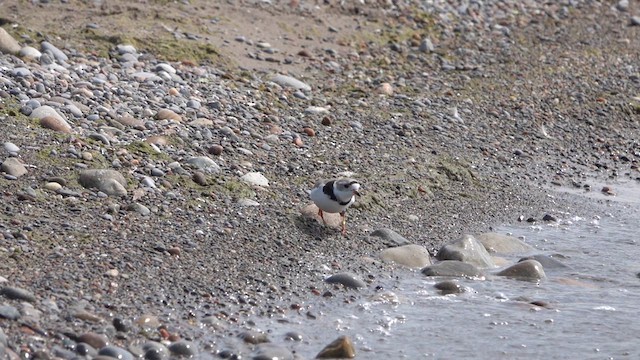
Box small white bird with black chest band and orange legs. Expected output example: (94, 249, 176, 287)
(309, 178, 360, 236)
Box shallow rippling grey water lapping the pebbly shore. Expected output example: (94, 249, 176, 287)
(249, 197, 640, 359)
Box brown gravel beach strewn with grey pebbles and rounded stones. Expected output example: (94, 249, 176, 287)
(0, 0, 640, 359)
